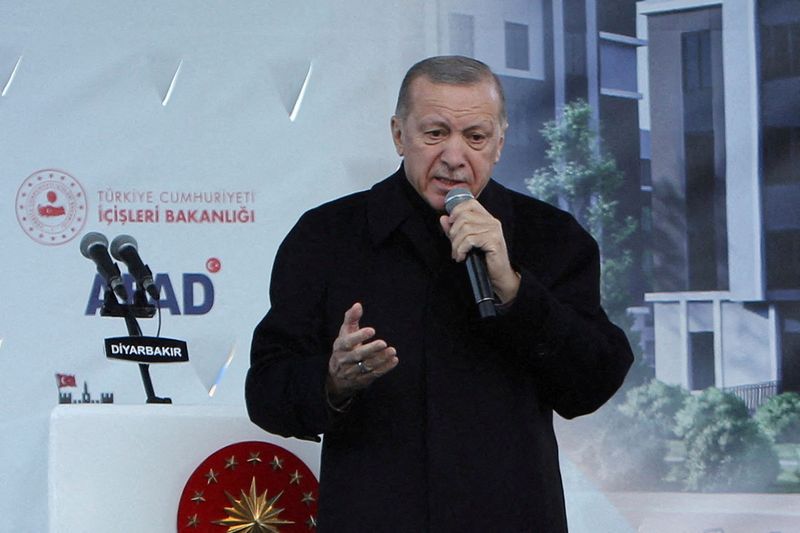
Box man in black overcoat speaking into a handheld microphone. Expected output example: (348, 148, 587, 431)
(246, 57, 632, 532)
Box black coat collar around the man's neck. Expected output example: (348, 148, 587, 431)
(367, 165, 513, 269)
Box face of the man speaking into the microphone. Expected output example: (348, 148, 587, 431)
(392, 76, 505, 211)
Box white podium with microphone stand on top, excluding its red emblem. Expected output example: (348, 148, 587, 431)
(48, 404, 320, 533)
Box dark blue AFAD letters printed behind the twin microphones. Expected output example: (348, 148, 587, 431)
(85, 273, 214, 315)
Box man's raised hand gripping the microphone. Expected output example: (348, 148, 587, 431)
(439, 200, 520, 303)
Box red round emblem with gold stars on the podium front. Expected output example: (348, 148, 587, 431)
(178, 441, 319, 533)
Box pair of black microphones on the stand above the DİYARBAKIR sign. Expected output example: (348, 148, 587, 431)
(80, 231, 158, 302)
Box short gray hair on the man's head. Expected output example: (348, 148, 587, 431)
(394, 56, 508, 126)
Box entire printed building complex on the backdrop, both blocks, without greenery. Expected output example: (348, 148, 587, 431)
(434, 0, 800, 408)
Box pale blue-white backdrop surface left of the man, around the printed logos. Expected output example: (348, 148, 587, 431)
(0, 0, 435, 531)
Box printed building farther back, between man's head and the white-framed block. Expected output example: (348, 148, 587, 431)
(432, 0, 654, 356)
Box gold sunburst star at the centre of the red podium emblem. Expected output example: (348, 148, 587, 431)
(214, 477, 294, 533)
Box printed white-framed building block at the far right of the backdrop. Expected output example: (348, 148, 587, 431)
(637, 0, 800, 402)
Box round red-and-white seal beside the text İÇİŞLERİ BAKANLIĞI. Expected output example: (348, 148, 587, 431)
(16, 169, 88, 245)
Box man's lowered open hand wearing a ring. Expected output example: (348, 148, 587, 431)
(327, 303, 399, 403)
